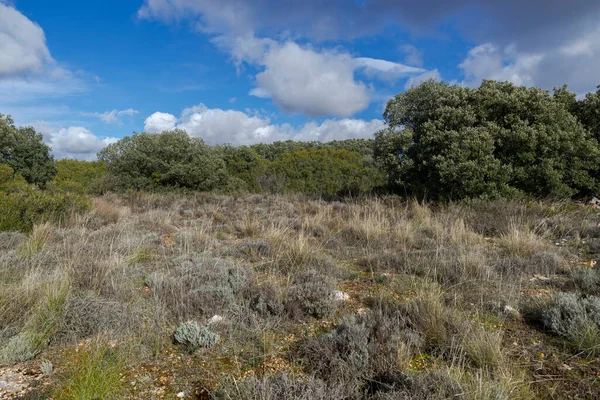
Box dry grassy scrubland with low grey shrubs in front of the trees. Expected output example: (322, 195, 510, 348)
(0, 193, 600, 400)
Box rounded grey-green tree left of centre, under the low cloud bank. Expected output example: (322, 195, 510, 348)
(98, 130, 227, 190)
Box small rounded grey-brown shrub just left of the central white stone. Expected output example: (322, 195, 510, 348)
(285, 271, 339, 318)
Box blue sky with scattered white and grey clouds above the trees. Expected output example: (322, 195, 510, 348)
(0, 0, 600, 159)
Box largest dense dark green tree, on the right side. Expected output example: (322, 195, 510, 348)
(374, 81, 600, 199)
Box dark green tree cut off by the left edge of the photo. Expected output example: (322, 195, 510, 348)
(0, 114, 56, 188)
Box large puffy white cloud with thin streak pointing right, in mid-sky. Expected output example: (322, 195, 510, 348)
(219, 34, 425, 117)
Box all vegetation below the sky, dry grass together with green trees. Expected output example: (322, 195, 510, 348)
(0, 81, 600, 400)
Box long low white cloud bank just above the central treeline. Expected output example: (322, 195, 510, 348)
(144, 104, 384, 145)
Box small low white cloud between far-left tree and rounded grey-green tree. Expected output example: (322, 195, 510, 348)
(31, 126, 118, 161)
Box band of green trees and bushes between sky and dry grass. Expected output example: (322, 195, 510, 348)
(0, 81, 600, 229)
